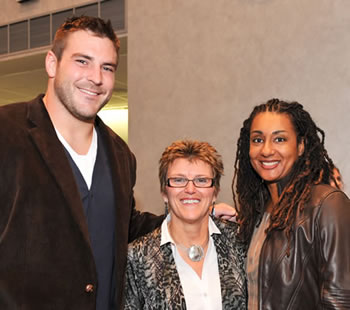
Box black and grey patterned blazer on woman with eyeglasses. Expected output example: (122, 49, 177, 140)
(125, 218, 247, 310)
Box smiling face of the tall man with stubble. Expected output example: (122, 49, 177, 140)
(54, 30, 117, 121)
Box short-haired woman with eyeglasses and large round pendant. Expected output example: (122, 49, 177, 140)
(125, 140, 247, 310)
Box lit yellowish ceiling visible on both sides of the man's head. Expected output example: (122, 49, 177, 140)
(0, 36, 128, 107)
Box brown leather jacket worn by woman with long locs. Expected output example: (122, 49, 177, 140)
(258, 185, 350, 310)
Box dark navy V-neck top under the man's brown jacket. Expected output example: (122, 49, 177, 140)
(65, 126, 115, 310)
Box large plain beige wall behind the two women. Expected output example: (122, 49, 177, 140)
(128, 0, 350, 213)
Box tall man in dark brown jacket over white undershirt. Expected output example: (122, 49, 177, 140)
(0, 17, 162, 310)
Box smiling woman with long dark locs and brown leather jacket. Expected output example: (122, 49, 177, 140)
(232, 99, 350, 310)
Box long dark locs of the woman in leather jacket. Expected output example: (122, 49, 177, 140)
(232, 99, 334, 242)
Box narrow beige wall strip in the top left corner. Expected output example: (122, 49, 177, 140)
(0, 0, 96, 25)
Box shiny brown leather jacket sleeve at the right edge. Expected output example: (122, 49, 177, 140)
(315, 191, 350, 309)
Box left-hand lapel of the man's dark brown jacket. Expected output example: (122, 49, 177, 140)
(27, 96, 91, 249)
